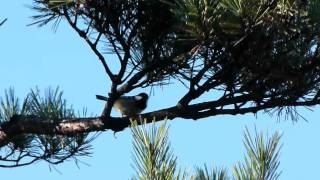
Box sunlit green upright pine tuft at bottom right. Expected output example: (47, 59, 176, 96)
(234, 129, 281, 180)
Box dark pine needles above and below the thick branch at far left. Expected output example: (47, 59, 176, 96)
(0, 88, 94, 167)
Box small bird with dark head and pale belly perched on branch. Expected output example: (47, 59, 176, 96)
(96, 93, 149, 116)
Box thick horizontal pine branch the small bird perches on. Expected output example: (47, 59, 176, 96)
(0, 96, 320, 144)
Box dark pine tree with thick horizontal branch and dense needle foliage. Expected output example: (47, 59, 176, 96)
(0, 0, 320, 169)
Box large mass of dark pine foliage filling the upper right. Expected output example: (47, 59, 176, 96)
(30, 0, 320, 118)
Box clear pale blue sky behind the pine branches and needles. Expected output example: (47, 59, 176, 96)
(0, 0, 320, 180)
